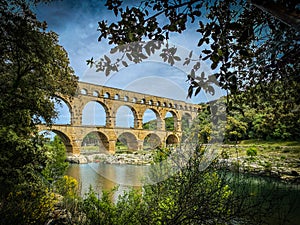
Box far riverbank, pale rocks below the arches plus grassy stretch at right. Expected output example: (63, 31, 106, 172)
(67, 144, 300, 184)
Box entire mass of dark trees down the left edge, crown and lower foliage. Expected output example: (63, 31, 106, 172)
(0, 0, 78, 203)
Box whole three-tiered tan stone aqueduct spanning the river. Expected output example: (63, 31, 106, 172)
(39, 82, 201, 155)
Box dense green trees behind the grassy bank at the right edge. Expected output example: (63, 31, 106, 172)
(233, 81, 300, 140)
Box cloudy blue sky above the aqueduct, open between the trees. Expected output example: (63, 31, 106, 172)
(36, 0, 221, 103)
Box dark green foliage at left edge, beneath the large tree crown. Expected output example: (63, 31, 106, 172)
(0, 127, 46, 197)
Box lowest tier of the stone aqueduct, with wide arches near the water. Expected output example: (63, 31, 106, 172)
(38, 125, 181, 155)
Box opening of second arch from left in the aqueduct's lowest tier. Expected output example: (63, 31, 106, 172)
(81, 131, 110, 153)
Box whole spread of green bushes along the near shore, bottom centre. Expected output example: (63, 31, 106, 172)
(75, 155, 237, 225)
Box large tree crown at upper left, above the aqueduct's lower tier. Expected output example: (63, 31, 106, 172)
(0, 1, 77, 130)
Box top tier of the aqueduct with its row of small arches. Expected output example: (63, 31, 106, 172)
(77, 81, 201, 112)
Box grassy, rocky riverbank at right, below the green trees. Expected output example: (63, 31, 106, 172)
(220, 142, 300, 184)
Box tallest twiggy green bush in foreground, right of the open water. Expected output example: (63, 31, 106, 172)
(144, 160, 232, 224)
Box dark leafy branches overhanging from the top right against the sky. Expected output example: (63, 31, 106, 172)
(88, 0, 300, 103)
